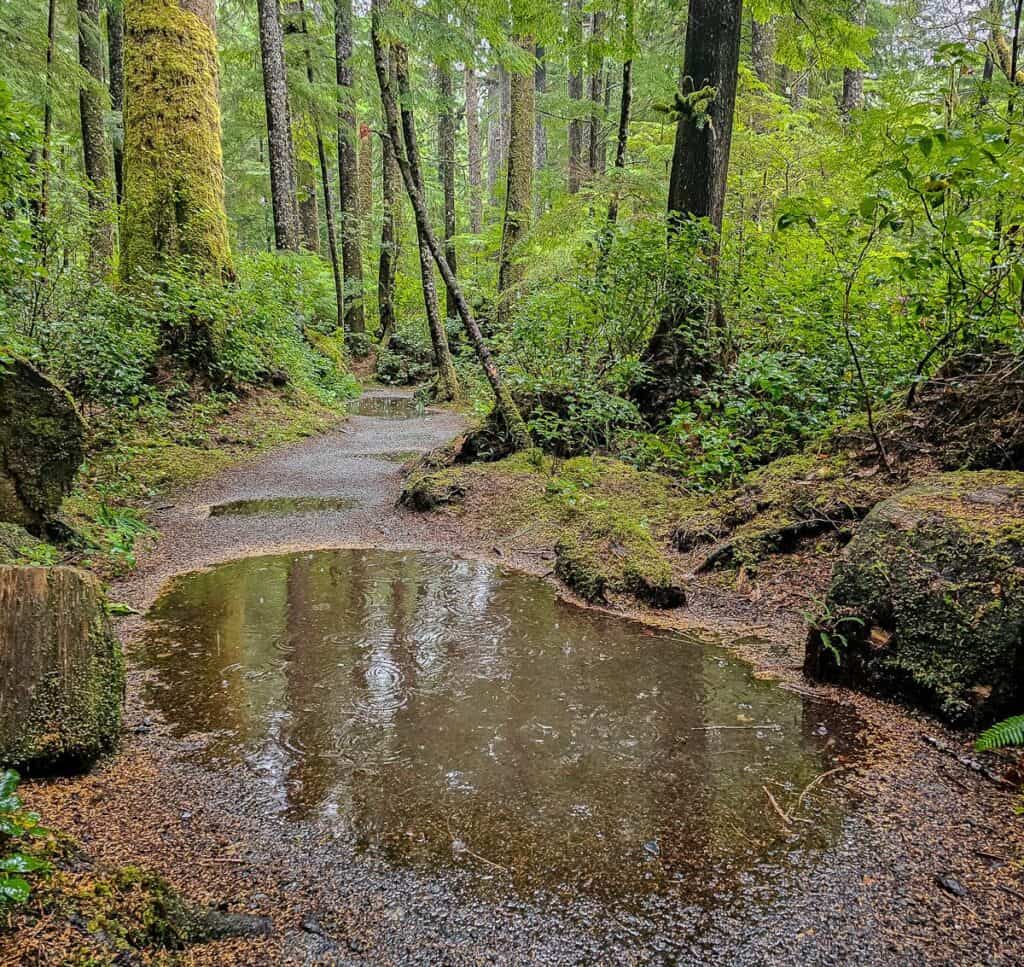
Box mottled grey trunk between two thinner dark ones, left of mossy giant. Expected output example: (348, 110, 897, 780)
(78, 0, 114, 275)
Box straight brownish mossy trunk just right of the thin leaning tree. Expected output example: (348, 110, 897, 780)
(498, 37, 535, 326)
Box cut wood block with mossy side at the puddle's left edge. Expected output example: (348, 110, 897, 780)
(0, 565, 124, 771)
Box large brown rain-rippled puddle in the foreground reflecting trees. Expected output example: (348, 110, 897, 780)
(143, 550, 852, 895)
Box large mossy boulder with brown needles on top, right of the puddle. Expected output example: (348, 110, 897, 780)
(805, 470, 1024, 725)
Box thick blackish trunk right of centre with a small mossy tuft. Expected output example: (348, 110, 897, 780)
(637, 0, 742, 418)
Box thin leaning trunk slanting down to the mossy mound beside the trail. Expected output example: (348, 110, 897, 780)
(371, 0, 531, 450)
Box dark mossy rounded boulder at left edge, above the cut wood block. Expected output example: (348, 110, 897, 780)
(0, 356, 85, 531)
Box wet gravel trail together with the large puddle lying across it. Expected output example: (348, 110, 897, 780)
(19, 394, 1024, 964)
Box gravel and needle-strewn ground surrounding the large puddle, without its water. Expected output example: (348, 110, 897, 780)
(8, 391, 1024, 965)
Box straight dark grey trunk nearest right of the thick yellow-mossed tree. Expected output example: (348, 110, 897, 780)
(257, 0, 302, 252)
